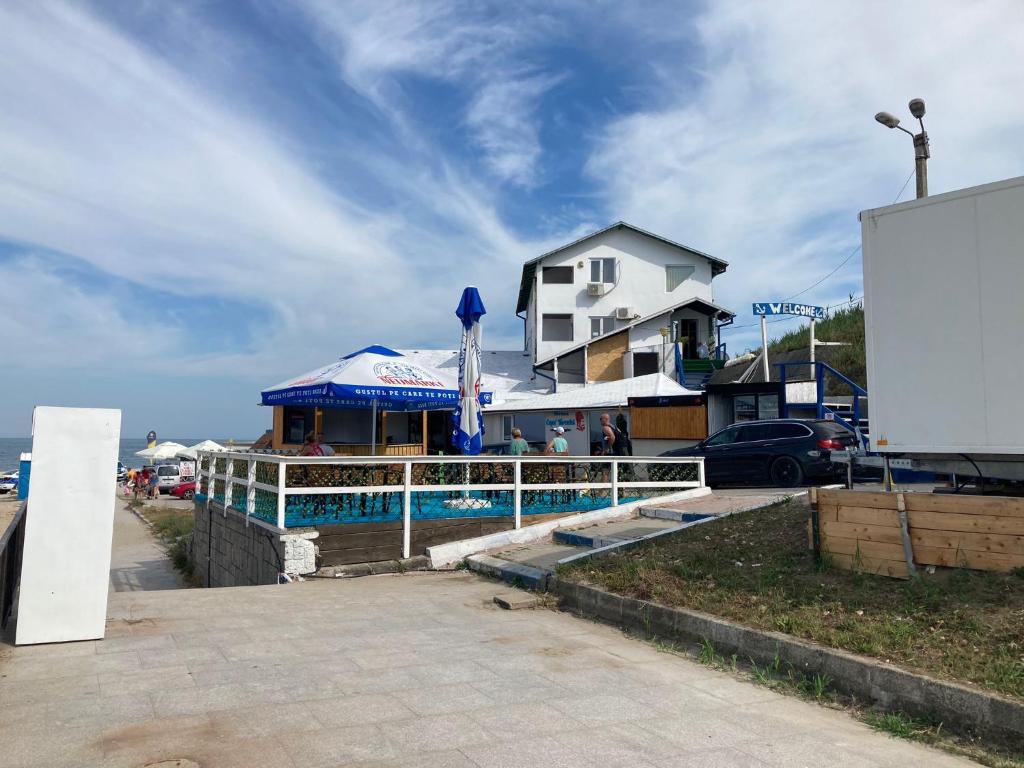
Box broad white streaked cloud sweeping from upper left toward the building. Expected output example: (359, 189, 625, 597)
(0, 3, 561, 381)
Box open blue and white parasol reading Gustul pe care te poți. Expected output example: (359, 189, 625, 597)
(261, 345, 459, 454)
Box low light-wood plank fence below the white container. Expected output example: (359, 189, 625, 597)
(810, 489, 1024, 579)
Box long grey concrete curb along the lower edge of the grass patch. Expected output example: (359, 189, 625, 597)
(548, 578, 1024, 751)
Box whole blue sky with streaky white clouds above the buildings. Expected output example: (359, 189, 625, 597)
(0, 0, 1024, 439)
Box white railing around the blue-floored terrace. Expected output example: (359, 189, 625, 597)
(196, 452, 705, 557)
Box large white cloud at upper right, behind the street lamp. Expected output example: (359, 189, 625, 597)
(589, 0, 1024, 343)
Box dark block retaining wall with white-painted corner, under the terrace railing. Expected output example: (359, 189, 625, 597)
(190, 501, 318, 587)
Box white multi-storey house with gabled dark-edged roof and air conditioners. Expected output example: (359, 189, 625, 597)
(516, 221, 733, 383)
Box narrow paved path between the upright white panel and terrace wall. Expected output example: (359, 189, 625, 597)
(108, 497, 184, 593)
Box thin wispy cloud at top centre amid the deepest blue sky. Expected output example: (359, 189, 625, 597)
(296, 0, 562, 186)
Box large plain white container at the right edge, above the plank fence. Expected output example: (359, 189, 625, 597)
(860, 177, 1024, 455)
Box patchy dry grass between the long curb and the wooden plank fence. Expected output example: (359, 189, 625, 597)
(560, 500, 1024, 699)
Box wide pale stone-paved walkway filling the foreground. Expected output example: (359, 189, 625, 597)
(0, 572, 968, 768)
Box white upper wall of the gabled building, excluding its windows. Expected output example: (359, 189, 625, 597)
(527, 229, 713, 359)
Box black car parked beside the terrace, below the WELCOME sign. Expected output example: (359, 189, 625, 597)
(662, 419, 857, 488)
